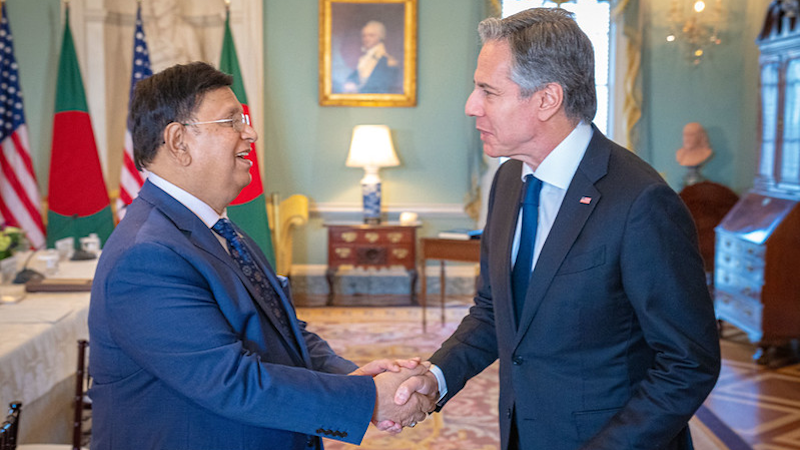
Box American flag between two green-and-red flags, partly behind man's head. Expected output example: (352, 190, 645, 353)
(117, 5, 153, 220)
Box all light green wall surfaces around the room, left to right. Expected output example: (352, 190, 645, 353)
(7, 0, 769, 264)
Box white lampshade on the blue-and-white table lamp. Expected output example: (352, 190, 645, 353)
(345, 125, 400, 168)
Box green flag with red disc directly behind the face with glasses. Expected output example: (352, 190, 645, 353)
(219, 11, 276, 268)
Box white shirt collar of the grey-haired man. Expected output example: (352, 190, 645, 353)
(522, 121, 593, 190)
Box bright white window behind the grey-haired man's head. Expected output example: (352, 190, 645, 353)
(503, 0, 611, 136)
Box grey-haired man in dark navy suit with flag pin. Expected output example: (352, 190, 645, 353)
(397, 8, 720, 450)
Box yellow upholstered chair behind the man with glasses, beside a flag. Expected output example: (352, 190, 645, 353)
(267, 194, 308, 277)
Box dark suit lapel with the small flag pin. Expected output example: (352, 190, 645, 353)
(509, 130, 610, 347)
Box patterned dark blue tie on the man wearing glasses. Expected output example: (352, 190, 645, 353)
(212, 219, 293, 336)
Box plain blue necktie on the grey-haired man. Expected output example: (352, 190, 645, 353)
(511, 175, 542, 326)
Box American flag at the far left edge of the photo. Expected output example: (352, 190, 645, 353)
(0, 3, 45, 248)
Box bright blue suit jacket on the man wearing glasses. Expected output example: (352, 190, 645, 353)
(89, 182, 375, 450)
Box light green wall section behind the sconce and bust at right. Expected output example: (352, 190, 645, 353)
(641, 0, 769, 193)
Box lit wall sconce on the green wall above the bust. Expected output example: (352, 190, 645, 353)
(667, 0, 722, 65)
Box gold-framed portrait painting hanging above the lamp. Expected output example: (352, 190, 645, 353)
(319, 0, 417, 106)
